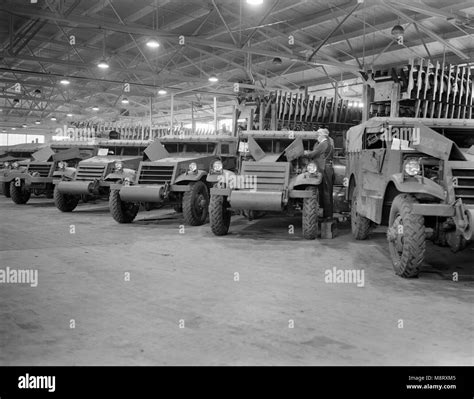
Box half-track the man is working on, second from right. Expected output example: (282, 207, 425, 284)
(209, 131, 345, 239)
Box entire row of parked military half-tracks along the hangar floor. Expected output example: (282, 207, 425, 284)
(0, 118, 474, 277)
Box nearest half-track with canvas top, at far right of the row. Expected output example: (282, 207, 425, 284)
(347, 118, 474, 277)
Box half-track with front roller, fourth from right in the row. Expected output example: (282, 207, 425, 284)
(54, 139, 150, 212)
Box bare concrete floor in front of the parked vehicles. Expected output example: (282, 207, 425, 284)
(0, 197, 474, 365)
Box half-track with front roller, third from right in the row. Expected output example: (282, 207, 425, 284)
(109, 135, 237, 226)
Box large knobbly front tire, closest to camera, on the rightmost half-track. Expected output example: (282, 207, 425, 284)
(387, 194, 426, 278)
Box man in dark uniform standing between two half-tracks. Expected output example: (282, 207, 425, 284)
(304, 129, 334, 220)
